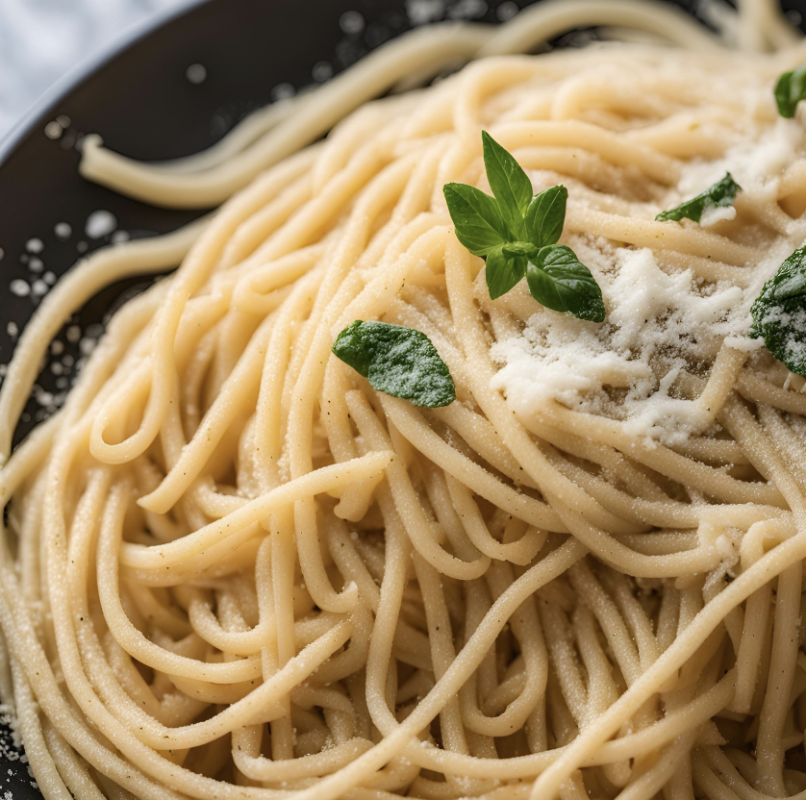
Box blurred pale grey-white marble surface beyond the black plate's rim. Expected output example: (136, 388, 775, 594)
(0, 0, 192, 140)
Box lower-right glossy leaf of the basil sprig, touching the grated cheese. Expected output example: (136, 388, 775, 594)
(526, 244, 605, 322)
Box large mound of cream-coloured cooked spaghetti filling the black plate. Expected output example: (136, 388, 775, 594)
(0, 4, 806, 800)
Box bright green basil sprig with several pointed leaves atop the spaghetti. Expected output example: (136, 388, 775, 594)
(443, 131, 605, 322)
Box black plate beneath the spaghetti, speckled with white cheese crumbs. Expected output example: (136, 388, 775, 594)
(0, 0, 806, 800)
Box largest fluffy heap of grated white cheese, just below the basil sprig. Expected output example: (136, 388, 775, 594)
(492, 240, 742, 442)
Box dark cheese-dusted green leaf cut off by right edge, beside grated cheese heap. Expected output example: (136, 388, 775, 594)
(750, 244, 806, 378)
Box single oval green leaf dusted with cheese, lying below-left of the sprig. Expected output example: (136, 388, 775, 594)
(333, 320, 456, 408)
